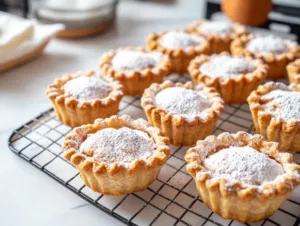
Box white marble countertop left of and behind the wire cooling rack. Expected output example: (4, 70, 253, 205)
(0, 0, 202, 226)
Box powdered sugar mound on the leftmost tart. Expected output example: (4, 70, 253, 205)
(64, 76, 112, 101)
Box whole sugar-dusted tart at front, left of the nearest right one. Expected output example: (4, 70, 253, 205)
(63, 115, 170, 196)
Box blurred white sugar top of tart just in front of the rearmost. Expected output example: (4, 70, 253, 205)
(159, 31, 206, 49)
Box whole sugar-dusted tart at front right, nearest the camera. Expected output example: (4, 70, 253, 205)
(185, 132, 300, 223)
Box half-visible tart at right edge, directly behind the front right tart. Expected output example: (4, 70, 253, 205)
(248, 82, 300, 152)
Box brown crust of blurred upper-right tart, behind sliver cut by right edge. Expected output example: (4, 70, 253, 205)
(230, 35, 300, 79)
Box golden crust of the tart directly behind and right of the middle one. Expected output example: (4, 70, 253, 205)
(188, 52, 268, 104)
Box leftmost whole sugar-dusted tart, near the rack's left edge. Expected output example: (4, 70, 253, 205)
(46, 71, 123, 127)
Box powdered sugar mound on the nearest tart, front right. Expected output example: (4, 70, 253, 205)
(203, 146, 284, 185)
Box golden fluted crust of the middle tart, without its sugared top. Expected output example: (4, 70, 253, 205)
(141, 81, 224, 146)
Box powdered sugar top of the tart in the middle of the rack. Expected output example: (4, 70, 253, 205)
(155, 87, 211, 120)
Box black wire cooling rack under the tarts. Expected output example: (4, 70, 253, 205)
(9, 75, 300, 226)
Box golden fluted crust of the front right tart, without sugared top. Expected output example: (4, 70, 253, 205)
(185, 132, 300, 222)
